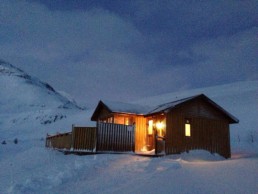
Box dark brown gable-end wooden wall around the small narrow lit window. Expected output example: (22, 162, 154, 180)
(166, 100, 230, 158)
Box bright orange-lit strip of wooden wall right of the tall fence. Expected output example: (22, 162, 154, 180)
(135, 116, 147, 151)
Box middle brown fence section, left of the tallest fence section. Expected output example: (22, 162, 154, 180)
(72, 127, 97, 152)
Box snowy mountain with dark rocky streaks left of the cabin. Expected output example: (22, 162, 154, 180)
(0, 60, 89, 139)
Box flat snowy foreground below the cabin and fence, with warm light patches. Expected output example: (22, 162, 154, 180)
(0, 139, 258, 194)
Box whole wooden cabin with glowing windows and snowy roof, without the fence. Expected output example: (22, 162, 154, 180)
(91, 94, 239, 158)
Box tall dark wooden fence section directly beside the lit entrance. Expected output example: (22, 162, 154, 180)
(97, 122, 134, 152)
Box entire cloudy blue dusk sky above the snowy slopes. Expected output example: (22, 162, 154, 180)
(0, 0, 258, 106)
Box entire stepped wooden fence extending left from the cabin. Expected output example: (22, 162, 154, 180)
(46, 122, 134, 153)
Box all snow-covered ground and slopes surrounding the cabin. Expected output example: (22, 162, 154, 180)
(0, 61, 258, 194)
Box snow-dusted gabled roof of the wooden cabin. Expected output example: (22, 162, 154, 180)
(91, 94, 239, 123)
